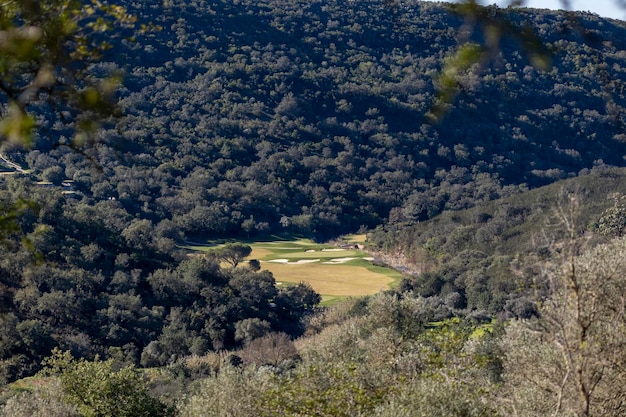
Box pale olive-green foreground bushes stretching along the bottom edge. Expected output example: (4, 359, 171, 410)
(7, 226, 626, 417)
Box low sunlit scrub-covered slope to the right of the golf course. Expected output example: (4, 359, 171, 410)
(368, 167, 626, 318)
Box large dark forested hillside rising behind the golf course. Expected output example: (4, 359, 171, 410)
(16, 1, 626, 237)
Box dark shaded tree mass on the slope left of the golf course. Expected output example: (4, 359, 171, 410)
(0, 177, 319, 380)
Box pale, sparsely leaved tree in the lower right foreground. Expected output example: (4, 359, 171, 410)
(501, 234, 626, 417)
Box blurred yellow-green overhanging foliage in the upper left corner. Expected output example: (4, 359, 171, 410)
(0, 0, 135, 146)
